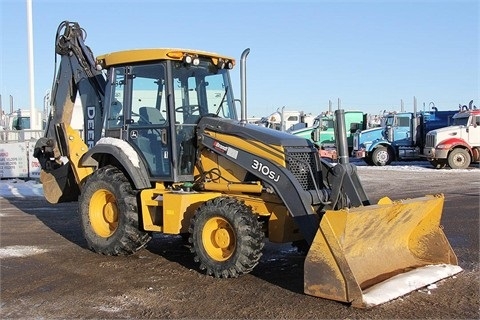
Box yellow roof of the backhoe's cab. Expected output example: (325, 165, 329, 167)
(97, 48, 235, 68)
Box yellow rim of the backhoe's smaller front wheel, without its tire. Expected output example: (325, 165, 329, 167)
(202, 217, 236, 261)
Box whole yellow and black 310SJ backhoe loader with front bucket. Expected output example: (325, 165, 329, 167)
(34, 21, 461, 307)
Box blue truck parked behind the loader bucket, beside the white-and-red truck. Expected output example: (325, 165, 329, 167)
(352, 108, 458, 166)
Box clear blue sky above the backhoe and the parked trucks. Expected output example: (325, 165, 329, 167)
(0, 0, 480, 116)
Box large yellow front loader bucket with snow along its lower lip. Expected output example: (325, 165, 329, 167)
(304, 195, 462, 308)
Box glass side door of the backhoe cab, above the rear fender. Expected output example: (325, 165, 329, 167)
(106, 63, 173, 180)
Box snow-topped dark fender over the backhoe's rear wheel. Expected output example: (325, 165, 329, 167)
(80, 138, 152, 189)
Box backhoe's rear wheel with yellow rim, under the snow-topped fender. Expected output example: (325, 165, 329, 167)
(79, 166, 151, 255)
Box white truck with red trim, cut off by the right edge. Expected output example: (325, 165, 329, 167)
(423, 109, 480, 169)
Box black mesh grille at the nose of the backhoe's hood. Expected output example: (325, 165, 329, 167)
(287, 151, 317, 190)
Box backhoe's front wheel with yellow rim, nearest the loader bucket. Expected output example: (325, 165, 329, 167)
(189, 197, 264, 278)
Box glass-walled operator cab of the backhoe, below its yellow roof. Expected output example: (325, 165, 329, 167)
(105, 51, 237, 182)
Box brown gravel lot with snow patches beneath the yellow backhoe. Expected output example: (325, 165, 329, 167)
(0, 163, 480, 319)
